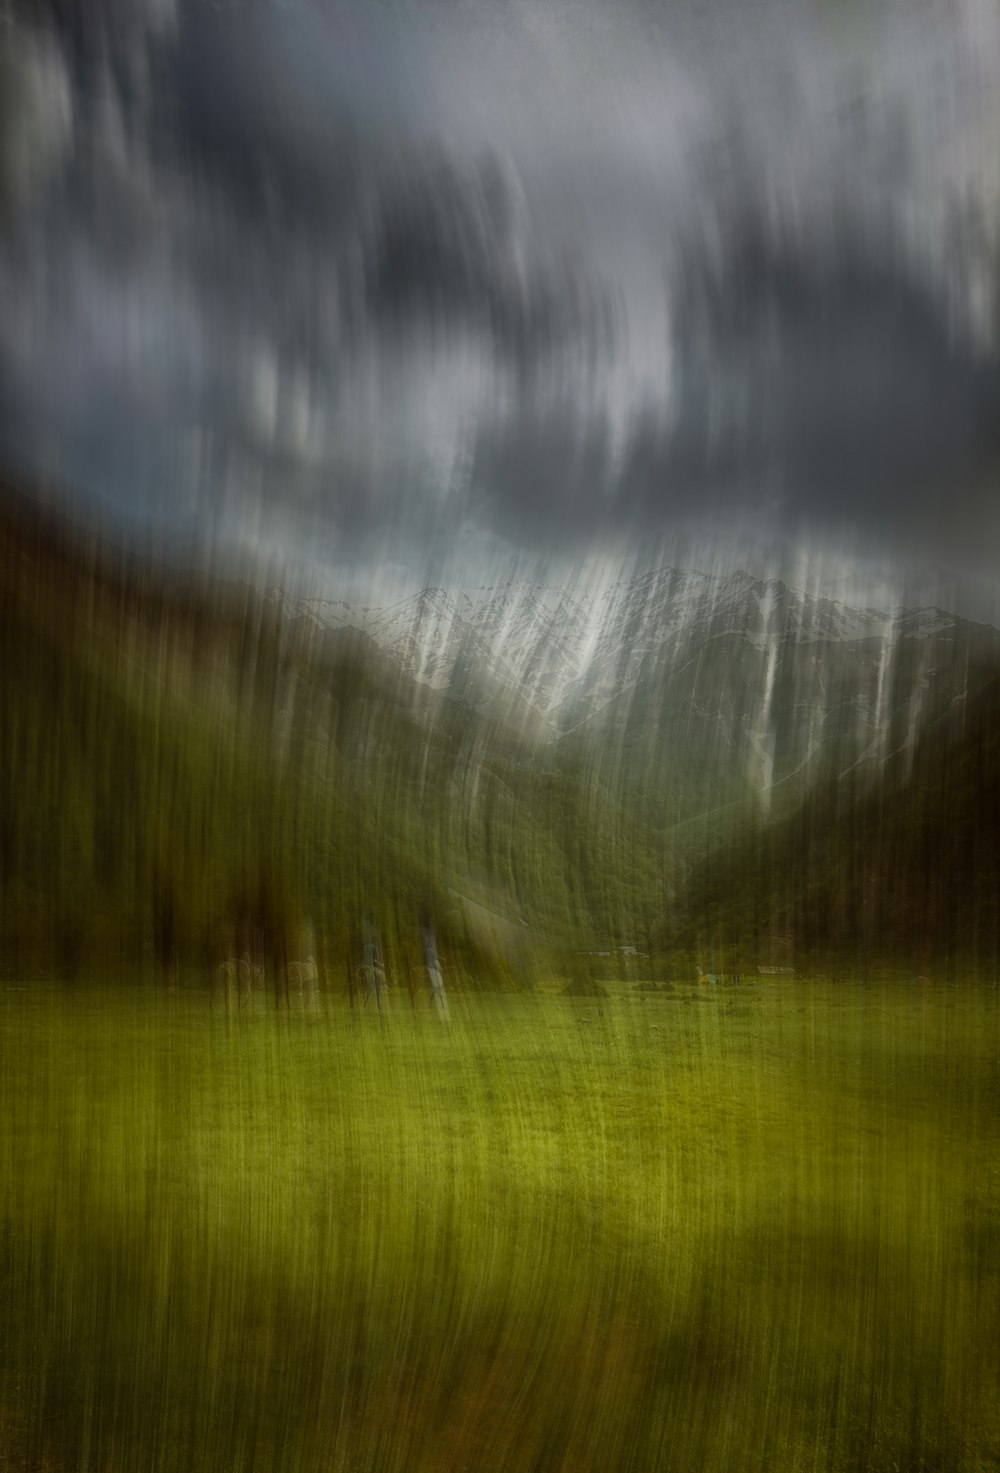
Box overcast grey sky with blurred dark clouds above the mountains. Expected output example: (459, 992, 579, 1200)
(0, 0, 1000, 609)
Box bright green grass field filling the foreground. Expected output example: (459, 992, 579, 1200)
(0, 982, 1000, 1473)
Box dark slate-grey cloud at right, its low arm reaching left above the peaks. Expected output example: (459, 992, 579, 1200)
(476, 218, 1000, 561)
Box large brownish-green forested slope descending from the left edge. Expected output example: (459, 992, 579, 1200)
(0, 496, 660, 981)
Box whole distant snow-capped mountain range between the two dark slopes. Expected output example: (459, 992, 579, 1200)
(273, 569, 1000, 788)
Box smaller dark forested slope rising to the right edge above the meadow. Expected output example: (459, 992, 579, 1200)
(677, 682, 1000, 980)
